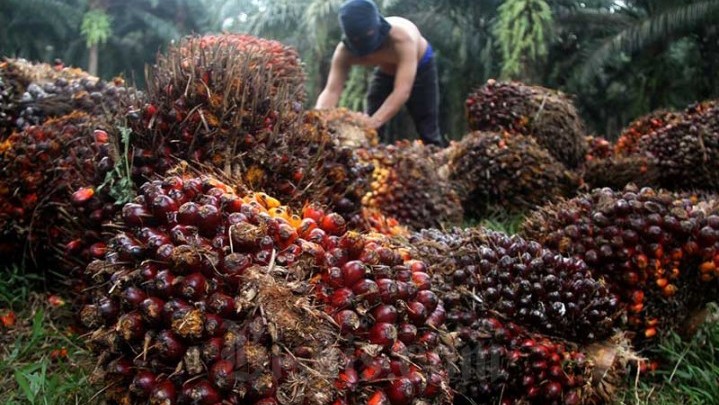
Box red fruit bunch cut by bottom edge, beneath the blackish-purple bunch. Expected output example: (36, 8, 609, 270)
(447, 316, 639, 405)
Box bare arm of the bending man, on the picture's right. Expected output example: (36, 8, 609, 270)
(370, 41, 418, 128)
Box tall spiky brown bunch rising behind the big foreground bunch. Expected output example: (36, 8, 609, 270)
(127, 34, 371, 219)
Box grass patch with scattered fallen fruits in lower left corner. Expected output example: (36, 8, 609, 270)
(0, 268, 99, 405)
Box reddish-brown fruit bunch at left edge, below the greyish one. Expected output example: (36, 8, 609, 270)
(0, 112, 119, 275)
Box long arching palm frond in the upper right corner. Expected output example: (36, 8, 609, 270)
(581, 0, 719, 80)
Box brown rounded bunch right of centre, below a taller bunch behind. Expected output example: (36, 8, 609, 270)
(442, 131, 579, 218)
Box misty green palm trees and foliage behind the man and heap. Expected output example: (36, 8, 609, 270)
(0, 0, 719, 138)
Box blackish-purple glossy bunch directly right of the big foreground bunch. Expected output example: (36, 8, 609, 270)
(410, 228, 622, 343)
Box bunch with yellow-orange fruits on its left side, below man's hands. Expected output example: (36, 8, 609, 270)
(356, 141, 463, 229)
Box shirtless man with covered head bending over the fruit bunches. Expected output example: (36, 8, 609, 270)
(315, 0, 445, 146)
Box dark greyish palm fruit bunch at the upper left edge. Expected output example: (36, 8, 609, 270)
(0, 59, 128, 137)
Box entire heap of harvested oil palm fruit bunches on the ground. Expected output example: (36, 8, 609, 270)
(7, 34, 719, 405)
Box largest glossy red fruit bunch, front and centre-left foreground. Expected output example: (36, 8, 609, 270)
(81, 176, 451, 405)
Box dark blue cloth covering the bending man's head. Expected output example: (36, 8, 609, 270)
(339, 0, 392, 56)
